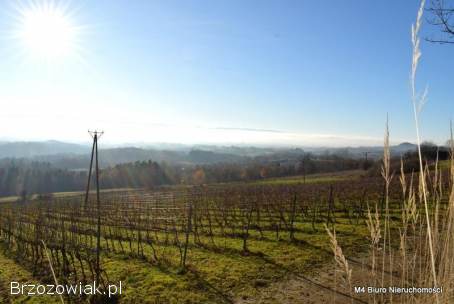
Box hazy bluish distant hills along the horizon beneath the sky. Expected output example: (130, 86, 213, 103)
(0, 141, 416, 170)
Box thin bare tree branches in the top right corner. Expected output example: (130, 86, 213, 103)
(426, 0, 454, 44)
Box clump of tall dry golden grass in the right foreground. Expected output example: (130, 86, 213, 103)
(327, 0, 454, 303)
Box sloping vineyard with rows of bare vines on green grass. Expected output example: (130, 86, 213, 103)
(0, 170, 449, 303)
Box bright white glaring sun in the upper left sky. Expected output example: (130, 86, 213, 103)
(16, 0, 78, 60)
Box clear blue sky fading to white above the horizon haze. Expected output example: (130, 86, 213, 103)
(0, 0, 454, 146)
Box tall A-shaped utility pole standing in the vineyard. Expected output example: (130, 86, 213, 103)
(85, 130, 104, 284)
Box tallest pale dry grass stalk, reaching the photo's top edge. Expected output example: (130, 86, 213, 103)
(410, 0, 438, 296)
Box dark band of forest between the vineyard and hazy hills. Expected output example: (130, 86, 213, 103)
(0, 154, 364, 196)
